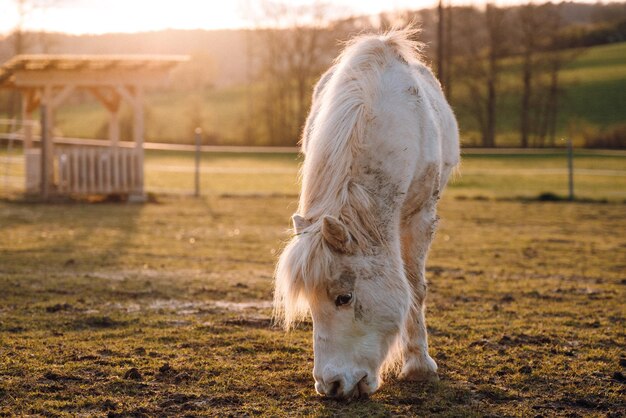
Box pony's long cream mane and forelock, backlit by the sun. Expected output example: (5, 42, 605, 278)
(274, 28, 421, 327)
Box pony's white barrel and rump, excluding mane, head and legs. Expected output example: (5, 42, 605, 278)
(361, 54, 459, 204)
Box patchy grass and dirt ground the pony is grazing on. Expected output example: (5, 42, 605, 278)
(0, 197, 626, 416)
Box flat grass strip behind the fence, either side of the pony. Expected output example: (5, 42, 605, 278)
(0, 149, 626, 202)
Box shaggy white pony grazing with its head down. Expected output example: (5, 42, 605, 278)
(274, 29, 459, 398)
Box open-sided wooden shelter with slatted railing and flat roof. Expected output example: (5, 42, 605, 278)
(0, 55, 187, 200)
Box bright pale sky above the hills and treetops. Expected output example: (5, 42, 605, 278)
(0, 0, 616, 34)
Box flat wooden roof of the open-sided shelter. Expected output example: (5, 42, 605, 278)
(0, 54, 189, 87)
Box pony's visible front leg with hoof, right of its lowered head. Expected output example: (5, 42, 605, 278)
(400, 197, 439, 381)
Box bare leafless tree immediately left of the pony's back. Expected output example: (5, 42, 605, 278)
(246, 0, 336, 145)
